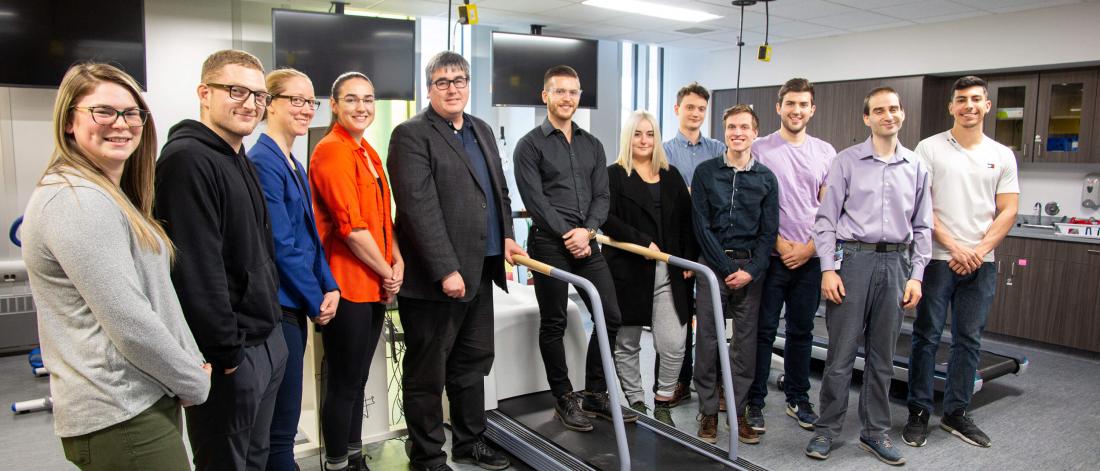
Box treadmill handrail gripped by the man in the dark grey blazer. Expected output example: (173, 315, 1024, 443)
(512, 255, 630, 471)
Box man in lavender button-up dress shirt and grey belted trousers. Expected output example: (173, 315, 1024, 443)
(805, 87, 932, 465)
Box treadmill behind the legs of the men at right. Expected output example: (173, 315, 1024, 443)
(772, 313, 1029, 393)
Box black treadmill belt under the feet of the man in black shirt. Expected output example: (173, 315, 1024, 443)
(498, 392, 761, 471)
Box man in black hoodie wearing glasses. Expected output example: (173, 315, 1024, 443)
(154, 51, 287, 470)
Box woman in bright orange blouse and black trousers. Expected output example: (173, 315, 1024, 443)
(309, 72, 405, 470)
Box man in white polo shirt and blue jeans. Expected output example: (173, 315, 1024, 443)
(902, 76, 1020, 447)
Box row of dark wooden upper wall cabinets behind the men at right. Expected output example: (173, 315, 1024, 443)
(711, 68, 1100, 163)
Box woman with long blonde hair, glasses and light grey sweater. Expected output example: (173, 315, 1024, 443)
(23, 63, 210, 470)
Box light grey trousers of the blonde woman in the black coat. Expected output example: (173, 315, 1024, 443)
(615, 262, 688, 404)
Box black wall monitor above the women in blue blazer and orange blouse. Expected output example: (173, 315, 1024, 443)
(272, 9, 416, 100)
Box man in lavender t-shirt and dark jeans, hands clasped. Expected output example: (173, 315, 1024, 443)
(745, 78, 836, 432)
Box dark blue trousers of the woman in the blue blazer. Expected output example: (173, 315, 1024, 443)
(267, 308, 307, 471)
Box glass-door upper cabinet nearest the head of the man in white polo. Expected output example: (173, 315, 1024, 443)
(985, 74, 1038, 162)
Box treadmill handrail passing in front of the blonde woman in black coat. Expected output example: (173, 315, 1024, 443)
(596, 234, 738, 461)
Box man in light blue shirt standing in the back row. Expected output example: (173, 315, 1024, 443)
(655, 81, 726, 407)
